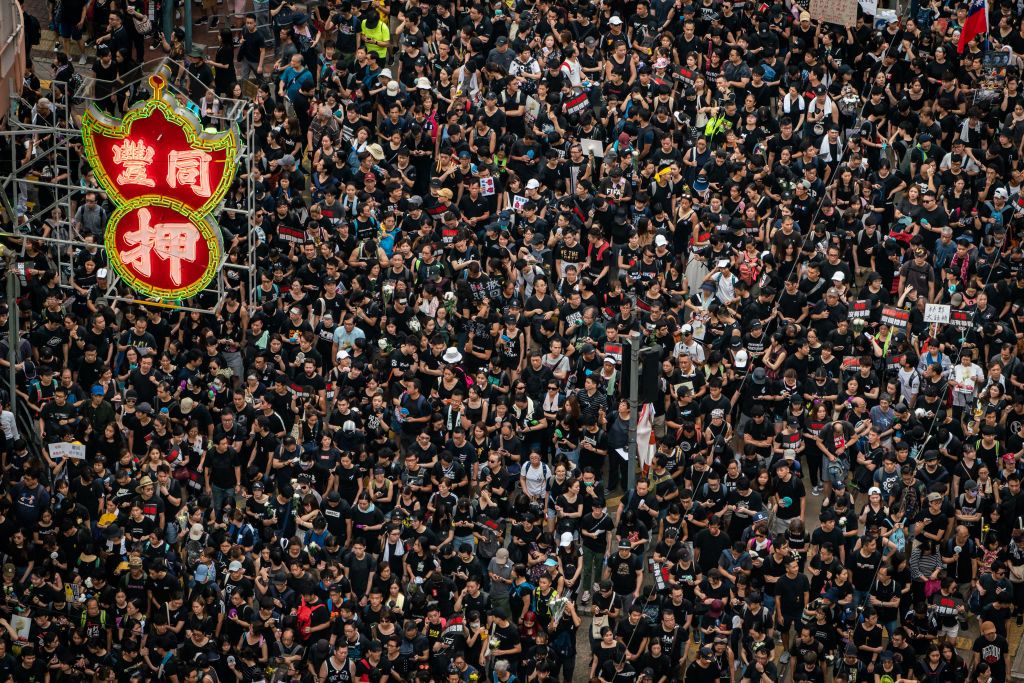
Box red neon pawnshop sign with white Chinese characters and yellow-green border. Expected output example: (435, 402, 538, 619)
(82, 68, 238, 301)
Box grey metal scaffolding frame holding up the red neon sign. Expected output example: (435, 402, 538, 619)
(0, 57, 257, 313)
